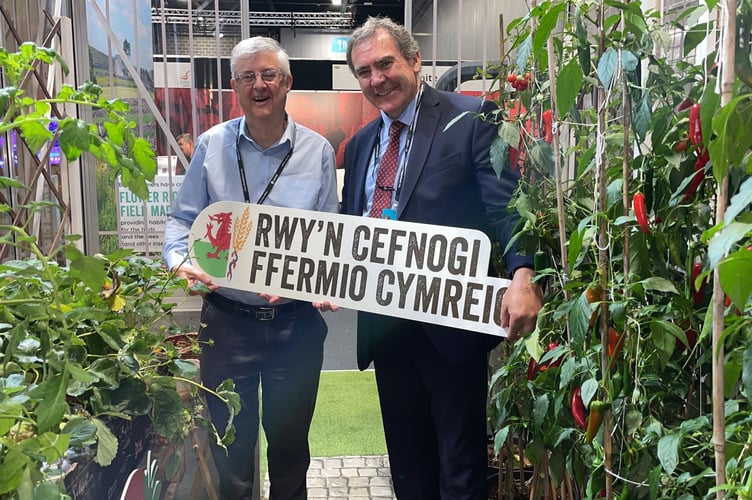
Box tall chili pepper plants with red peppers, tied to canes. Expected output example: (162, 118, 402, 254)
(490, 0, 752, 499)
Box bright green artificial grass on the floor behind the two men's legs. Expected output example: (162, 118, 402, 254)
(259, 370, 386, 477)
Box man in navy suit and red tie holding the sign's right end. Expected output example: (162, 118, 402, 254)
(342, 18, 542, 500)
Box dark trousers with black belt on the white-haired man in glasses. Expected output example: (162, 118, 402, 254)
(199, 300, 327, 500)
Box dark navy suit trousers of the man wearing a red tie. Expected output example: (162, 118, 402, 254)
(373, 321, 488, 500)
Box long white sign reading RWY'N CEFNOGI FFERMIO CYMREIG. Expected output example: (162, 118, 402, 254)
(189, 201, 510, 336)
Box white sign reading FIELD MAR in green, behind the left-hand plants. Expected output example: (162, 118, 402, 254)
(116, 175, 183, 254)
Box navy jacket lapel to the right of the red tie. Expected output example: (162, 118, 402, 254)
(397, 85, 441, 218)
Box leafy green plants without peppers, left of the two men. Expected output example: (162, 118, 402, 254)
(0, 43, 239, 499)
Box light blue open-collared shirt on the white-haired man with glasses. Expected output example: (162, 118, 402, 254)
(167, 117, 339, 304)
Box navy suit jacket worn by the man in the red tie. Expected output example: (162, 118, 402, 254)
(342, 85, 532, 369)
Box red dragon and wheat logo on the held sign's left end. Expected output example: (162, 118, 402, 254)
(194, 208, 253, 280)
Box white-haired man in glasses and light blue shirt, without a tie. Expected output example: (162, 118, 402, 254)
(167, 37, 339, 500)
